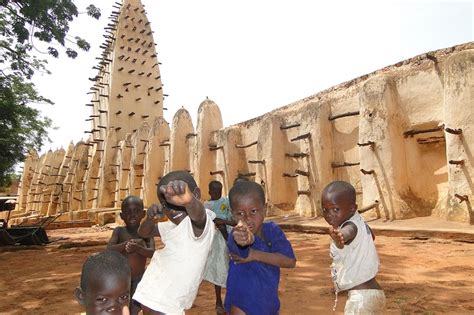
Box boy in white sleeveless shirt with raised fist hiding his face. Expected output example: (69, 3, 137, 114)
(133, 171, 215, 314)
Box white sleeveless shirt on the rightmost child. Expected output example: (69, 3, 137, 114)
(330, 212, 380, 292)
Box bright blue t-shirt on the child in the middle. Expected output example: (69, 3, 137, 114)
(224, 222, 295, 315)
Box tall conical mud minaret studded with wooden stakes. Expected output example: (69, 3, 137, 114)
(86, 0, 163, 142)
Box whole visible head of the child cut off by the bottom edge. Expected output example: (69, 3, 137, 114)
(74, 251, 131, 315)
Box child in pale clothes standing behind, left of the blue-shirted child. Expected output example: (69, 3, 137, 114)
(204, 180, 235, 314)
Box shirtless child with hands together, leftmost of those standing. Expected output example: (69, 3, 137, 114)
(107, 196, 155, 315)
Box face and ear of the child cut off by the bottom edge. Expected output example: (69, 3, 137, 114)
(76, 275, 130, 315)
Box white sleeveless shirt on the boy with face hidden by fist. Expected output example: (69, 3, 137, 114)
(133, 209, 215, 314)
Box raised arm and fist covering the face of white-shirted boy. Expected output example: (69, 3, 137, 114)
(160, 180, 206, 237)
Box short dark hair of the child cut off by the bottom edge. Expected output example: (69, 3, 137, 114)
(81, 250, 131, 292)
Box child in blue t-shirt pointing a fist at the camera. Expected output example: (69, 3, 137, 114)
(224, 181, 296, 315)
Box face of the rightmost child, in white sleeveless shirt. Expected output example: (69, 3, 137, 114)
(321, 193, 357, 228)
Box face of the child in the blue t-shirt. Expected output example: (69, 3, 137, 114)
(231, 193, 266, 235)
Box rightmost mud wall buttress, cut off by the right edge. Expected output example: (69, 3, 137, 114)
(438, 50, 474, 224)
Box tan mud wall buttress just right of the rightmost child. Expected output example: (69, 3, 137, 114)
(359, 76, 413, 220)
